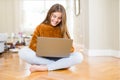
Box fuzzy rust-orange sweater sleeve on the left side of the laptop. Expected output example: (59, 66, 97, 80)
(29, 25, 41, 51)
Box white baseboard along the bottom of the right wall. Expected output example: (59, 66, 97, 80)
(84, 49, 120, 58)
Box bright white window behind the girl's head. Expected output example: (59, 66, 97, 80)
(22, 0, 66, 33)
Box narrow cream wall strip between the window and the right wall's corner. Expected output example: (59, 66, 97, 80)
(73, 0, 88, 48)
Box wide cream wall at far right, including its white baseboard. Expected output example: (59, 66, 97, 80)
(86, 0, 119, 56)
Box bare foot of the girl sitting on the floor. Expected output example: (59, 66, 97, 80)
(30, 65, 48, 72)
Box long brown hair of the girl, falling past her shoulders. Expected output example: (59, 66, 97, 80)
(42, 4, 70, 38)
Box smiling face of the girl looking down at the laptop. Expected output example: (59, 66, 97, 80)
(50, 12, 62, 26)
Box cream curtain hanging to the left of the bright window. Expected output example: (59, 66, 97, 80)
(0, 0, 22, 34)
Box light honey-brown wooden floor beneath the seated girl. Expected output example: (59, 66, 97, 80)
(0, 53, 120, 80)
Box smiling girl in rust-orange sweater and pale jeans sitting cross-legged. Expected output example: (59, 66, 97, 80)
(19, 4, 83, 72)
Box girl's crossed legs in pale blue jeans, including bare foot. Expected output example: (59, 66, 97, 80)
(19, 47, 83, 72)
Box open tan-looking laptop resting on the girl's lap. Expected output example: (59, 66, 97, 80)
(36, 37, 73, 57)
